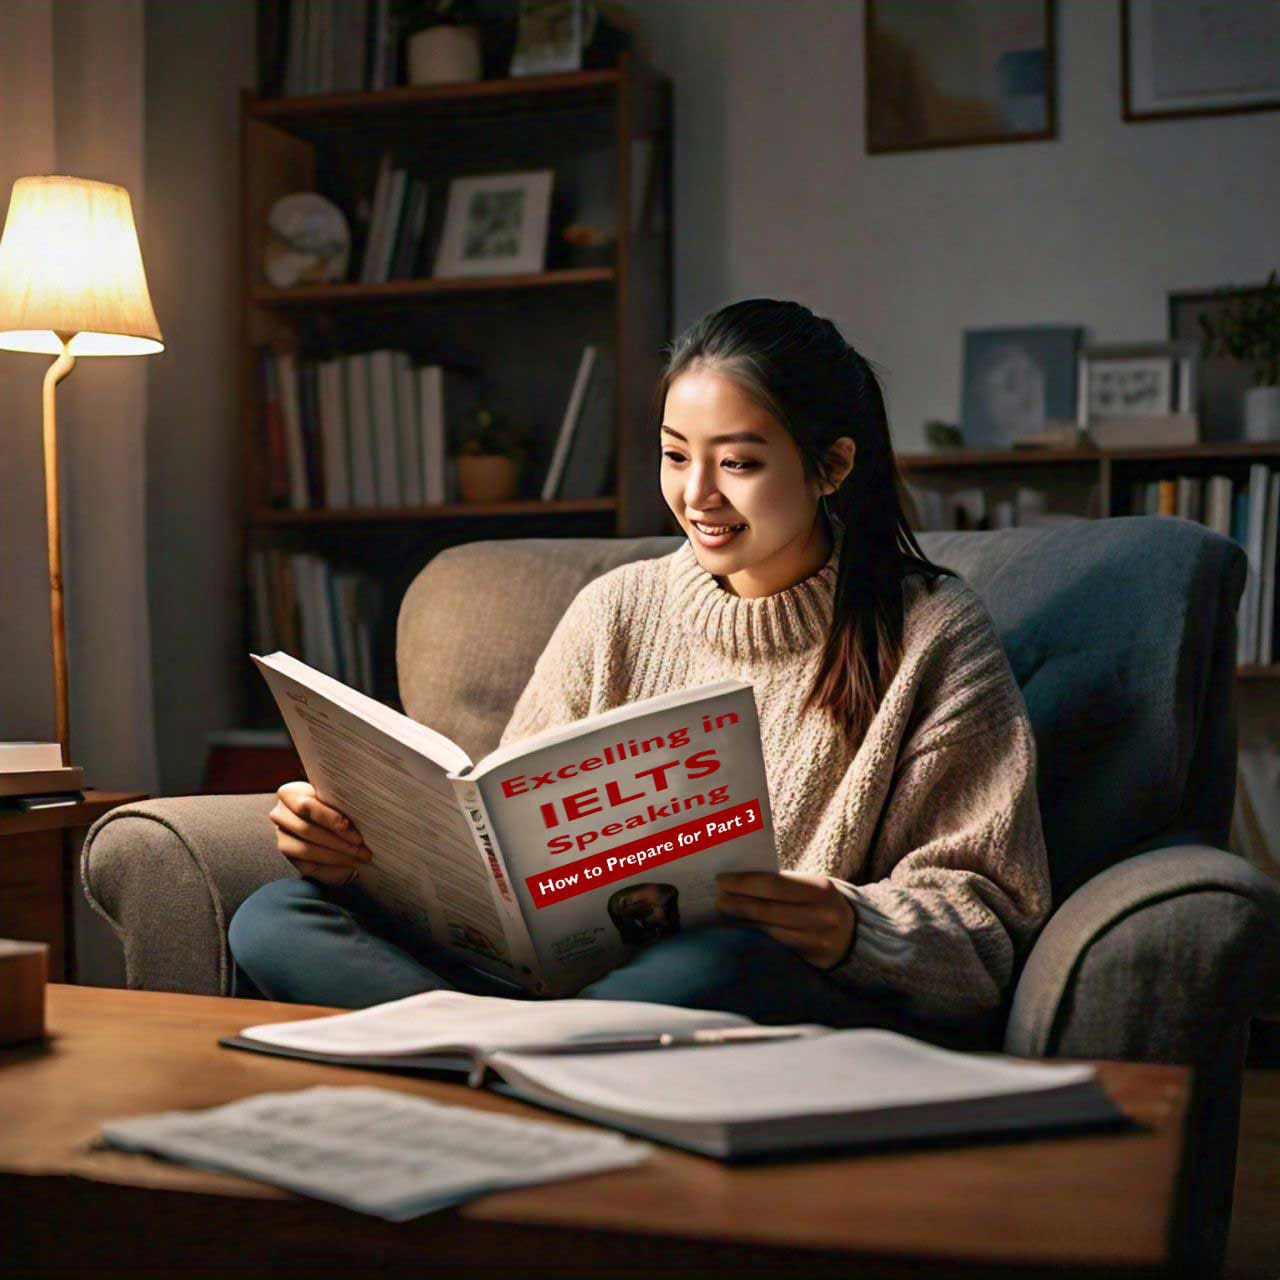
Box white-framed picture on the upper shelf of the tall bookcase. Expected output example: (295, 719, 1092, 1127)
(434, 169, 552, 275)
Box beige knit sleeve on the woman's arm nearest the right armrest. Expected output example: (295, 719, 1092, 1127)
(832, 588, 1050, 1023)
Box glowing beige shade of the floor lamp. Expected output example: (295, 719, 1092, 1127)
(0, 177, 164, 356)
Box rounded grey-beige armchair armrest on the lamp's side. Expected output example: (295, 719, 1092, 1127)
(81, 795, 294, 996)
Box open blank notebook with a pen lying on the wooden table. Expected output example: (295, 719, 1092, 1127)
(223, 991, 1125, 1158)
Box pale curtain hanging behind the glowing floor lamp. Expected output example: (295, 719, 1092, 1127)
(0, 0, 164, 790)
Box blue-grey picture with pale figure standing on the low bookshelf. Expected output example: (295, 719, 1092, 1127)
(960, 325, 1082, 449)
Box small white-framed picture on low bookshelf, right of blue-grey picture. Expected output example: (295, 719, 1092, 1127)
(1076, 342, 1199, 449)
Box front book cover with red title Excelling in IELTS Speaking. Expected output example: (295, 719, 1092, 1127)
(475, 680, 778, 995)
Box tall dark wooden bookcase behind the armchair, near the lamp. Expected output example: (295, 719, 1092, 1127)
(241, 54, 672, 723)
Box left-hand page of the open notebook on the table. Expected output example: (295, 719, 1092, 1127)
(241, 991, 751, 1060)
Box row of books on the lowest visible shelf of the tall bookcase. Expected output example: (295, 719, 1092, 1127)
(248, 547, 380, 696)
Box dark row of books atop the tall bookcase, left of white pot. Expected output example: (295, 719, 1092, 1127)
(275, 0, 398, 97)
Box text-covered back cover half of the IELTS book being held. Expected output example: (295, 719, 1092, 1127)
(253, 654, 517, 980)
